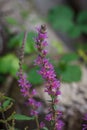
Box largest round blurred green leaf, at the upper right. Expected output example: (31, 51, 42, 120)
(48, 6, 74, 32)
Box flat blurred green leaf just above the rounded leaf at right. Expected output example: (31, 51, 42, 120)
(59, 53, 79, 63)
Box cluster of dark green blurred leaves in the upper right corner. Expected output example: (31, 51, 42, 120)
(48, 5, 87, 38)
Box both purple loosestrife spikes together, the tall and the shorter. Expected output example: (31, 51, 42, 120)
(18, 25, 64, 130)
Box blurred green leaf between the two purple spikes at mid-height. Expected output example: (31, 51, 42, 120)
(28, 67, 43, 85)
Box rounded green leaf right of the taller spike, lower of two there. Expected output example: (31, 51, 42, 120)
(56, 65, 82, 82)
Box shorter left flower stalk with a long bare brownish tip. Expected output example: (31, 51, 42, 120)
(17, 32, 41, 130)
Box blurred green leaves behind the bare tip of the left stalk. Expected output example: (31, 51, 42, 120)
(8, 32, 36, 53)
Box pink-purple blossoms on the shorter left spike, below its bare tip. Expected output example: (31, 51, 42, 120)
(18, 73, 41, 115)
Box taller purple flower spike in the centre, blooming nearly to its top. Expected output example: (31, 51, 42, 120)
(35, 25, 64, 130)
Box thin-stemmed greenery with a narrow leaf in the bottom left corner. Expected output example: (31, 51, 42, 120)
(0, 93, 35, 130)
